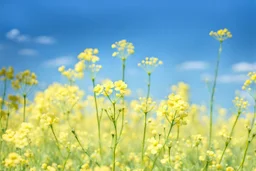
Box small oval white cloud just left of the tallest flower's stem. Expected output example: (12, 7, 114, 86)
(178, 61, 208, 70)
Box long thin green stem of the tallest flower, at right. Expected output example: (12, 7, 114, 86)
(208, 41, 222, 149)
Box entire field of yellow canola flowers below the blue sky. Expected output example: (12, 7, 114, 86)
(0, 29, 256, 171)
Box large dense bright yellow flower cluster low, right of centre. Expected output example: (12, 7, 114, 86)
(157, 94, 189, 125)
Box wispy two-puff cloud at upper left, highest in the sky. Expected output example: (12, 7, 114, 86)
(6, 29, 56, 45)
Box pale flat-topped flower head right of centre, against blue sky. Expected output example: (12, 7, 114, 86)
(138, 57, 163, 74)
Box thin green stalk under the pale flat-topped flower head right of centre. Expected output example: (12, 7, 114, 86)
(141, 72, 151, 163)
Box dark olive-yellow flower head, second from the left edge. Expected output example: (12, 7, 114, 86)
(12, 70, 38, 94)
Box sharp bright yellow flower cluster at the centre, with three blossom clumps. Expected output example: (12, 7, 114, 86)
(94, 80, 129, 101)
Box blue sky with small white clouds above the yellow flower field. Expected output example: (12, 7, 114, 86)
(0, 0, 256, 111)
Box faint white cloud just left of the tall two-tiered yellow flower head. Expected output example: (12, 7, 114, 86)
(43, 56, 74, 68)
